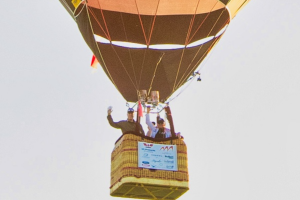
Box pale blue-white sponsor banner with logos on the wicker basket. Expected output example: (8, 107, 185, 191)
(138, 142, 178, 171)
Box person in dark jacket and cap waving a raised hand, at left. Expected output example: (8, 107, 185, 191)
(107, 107, 145, 135)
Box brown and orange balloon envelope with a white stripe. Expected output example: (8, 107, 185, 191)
(60, 0, 248, 102)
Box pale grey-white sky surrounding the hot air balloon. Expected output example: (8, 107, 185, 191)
(0, 0, 300, 200)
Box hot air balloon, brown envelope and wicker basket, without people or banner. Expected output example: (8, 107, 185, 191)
(60, 0, 250, 199)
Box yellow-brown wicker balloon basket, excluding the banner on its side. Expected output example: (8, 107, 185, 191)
(110, 134, 189, 199)
